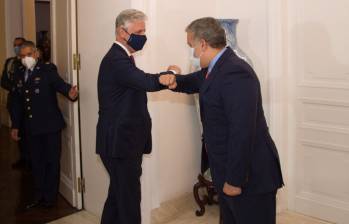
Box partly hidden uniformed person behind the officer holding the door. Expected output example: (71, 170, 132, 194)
(1, 37, 29, 169)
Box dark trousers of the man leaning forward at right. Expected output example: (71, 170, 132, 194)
(219, 192, 276, 224)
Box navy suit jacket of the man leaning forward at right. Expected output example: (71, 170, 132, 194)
(175, 48, 283, 194)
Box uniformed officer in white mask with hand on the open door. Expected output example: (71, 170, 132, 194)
(11, 41, 78, 209)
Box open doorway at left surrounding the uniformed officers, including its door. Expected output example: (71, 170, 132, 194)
(0, 0, 82, 224)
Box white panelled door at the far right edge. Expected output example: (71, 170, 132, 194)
(288, 0, 349, 224)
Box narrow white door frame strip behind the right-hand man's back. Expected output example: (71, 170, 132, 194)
(268, 0, 292, 212)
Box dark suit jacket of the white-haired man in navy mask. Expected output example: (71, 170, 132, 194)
(96, 44, 165, 158)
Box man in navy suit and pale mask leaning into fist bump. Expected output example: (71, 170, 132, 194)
(163, 18, 283, 224)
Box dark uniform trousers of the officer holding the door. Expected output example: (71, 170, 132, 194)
(27, 131, 62, 203)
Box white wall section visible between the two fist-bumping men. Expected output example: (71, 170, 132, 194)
(149, 0, 214, 202)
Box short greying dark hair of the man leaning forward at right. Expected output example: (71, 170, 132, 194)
(185, 17, 227, 48)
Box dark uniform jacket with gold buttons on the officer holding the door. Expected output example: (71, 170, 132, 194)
(11, 63, 71, 135)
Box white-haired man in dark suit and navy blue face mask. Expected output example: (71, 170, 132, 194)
(96, 9, 174, 224)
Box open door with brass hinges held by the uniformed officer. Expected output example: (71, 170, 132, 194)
(51, 0, 82, 209)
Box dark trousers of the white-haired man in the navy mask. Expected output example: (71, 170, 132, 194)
(100, 155, 143, 224)
